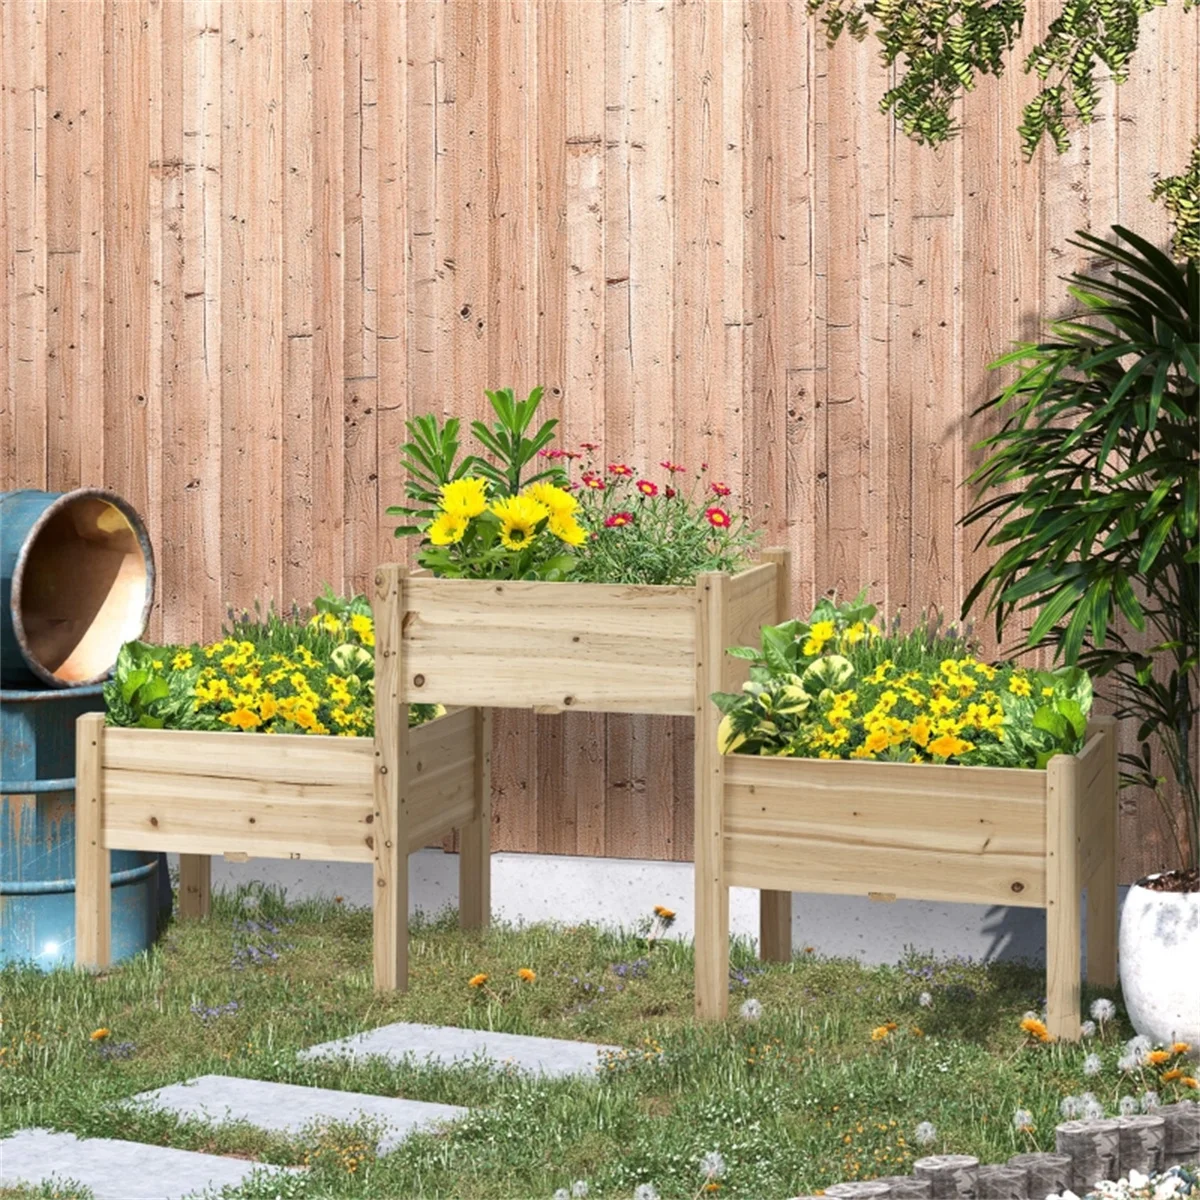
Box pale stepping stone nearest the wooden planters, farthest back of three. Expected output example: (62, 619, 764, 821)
(300, 1021, 620, 1079)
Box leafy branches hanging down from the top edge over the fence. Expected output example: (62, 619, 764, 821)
(809, 0, 1195, 155)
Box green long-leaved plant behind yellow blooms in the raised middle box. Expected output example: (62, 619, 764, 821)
(385, 388, 564, 538)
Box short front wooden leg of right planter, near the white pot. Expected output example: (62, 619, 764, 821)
(1046, 755, 1082, 1042)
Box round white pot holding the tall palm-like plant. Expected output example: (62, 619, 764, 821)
(1120, 876, 1200, 1045)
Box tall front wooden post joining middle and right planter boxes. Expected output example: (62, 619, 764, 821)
(695, 575, 730, 1020)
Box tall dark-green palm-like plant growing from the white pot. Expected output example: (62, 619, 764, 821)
(964, 226, 1200, 865)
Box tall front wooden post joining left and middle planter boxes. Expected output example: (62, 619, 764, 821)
(372, 565, 408, 991)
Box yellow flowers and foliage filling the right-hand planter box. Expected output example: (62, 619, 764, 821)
(713, 595, 1092, 768)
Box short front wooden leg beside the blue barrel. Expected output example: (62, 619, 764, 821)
(76, 713, 113, 970)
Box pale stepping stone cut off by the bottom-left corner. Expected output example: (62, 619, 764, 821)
(0, 1129, 295, 1200)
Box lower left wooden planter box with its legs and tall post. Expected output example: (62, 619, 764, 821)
(76, 566, 491, 990)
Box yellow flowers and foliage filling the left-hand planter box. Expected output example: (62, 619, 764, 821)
(104, 592, 444, 737)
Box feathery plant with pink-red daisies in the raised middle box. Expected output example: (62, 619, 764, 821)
(571, 444, 758, 584)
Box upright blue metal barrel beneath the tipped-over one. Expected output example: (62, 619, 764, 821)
(0, 685, 162, 968)
